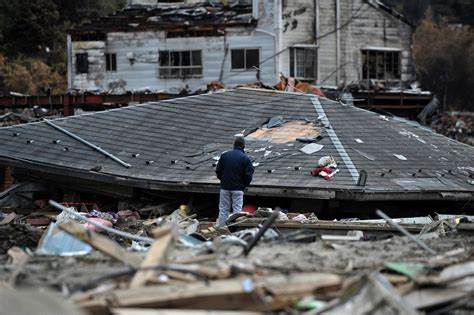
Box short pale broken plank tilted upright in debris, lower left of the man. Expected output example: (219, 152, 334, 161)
(130, 227, 174, 288)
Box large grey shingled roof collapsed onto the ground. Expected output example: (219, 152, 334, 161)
(0, 89, 474, 200)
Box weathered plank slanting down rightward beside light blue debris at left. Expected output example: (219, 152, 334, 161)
(58, 222, 142, 268)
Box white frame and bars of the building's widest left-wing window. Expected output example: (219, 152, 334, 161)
(158, 49, 203, 79)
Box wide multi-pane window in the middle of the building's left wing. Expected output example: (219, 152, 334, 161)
(158, 50, 202, 78)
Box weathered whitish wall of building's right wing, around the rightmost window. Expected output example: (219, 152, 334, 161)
(318, 0, 414, 85)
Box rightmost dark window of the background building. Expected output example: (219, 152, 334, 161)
(362, 49, 401, 81)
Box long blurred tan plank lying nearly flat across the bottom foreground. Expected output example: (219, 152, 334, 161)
(79, 273, 342, 311)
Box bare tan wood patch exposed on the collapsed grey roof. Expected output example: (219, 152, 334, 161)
(248, 120, 321, 143)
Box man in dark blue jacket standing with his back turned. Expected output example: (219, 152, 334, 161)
(216, 137, 254, 228)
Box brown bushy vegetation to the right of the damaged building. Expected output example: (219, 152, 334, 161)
(413, 10, 474, 111)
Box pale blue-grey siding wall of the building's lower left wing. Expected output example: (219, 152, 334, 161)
(70, 0, 278, 93)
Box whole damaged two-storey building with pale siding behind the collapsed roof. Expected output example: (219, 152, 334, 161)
(68, 0, 414, 93)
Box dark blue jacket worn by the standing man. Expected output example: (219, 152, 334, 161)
(216, 147, 254, 190)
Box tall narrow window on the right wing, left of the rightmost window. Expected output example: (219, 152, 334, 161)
(290, 47, 318, 81)
